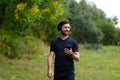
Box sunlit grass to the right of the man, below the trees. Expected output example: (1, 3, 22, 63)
(76, 46, 120, 80)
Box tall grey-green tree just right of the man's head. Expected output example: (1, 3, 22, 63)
(68, 0, 102, 44)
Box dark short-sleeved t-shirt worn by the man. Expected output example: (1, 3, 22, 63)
(50, 37, 78, 71)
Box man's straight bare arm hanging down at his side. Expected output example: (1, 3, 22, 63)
(47, 51, 54, 78)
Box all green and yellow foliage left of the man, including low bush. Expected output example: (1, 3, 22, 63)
(0, 0, 66, 58)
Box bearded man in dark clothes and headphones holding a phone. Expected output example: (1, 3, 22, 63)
(47, 20, 80, 80)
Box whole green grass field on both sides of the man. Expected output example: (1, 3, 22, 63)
(0, 46, 120, 80)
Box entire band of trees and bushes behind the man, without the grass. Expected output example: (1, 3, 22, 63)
(0, 0, 120, 58)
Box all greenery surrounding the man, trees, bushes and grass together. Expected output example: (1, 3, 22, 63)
(0, 0, 120, 80)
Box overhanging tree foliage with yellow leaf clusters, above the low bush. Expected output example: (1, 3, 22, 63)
(0, 0, 65, 41)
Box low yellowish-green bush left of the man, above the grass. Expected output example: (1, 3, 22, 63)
(0, 36, 47, 59)
